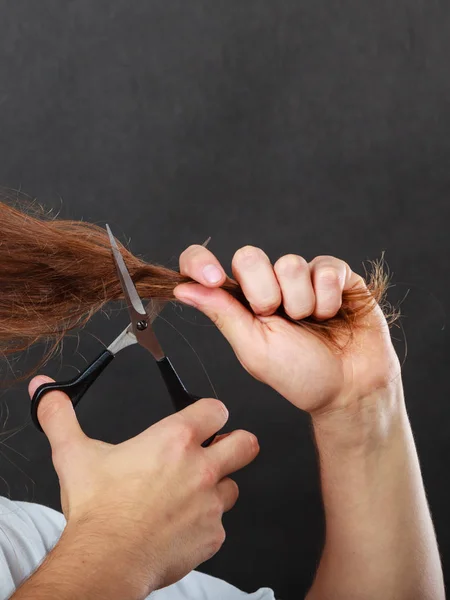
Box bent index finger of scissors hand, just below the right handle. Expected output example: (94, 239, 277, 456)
(159, 398, 228, 445)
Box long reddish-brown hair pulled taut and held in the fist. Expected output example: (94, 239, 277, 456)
(0, 192, 398, 380)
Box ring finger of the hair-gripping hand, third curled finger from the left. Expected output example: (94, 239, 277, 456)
(273, 254, 316, 320)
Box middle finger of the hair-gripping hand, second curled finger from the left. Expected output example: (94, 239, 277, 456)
(231, 246, 281, 317)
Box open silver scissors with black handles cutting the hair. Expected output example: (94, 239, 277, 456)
(31, 225, 217, 447)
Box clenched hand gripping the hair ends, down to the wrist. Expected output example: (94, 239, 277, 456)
(174, 245, 400, 417)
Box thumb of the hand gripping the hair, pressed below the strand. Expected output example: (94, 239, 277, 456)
(174, 283, 256, 353)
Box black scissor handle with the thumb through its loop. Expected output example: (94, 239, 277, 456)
(31, 350, 114, 431)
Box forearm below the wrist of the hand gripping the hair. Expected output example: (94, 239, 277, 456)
(307, 386, 445, 600)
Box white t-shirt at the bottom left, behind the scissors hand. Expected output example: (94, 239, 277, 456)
(0, 496, 275, 600)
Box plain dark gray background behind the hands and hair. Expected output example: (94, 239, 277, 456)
(0, 0, 450, 600)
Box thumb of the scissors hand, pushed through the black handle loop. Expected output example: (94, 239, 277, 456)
(28, 375, 86, 451)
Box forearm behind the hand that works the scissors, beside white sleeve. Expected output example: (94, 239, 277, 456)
(11, 528, 153, 600)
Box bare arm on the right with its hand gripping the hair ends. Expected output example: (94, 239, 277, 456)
(174, 246, 445, 600)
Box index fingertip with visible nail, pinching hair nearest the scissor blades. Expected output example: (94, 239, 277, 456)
(180, 244, 226, 287)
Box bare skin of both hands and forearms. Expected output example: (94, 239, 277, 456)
(13, 245, 445, 600)
